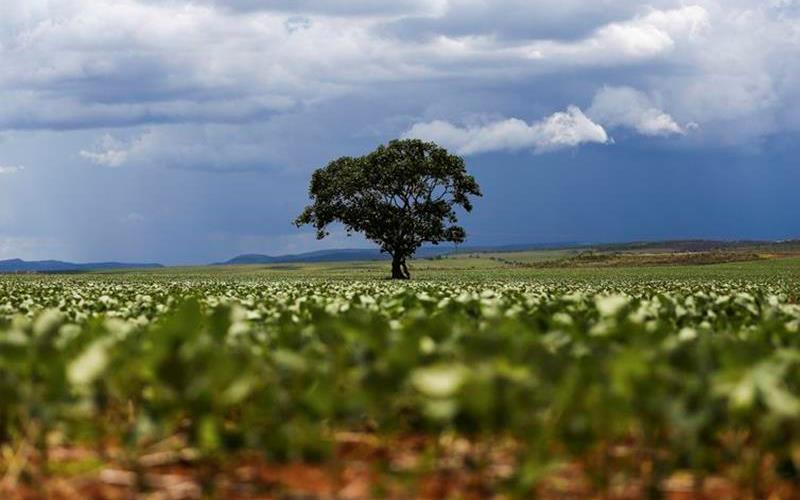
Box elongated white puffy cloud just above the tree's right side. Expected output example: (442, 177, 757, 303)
(404, 106, 609, 155)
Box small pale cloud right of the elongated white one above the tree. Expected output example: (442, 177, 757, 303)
(586, 87, 697, 136)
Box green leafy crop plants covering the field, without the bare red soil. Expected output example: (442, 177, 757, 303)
(0, 267, 800, 496)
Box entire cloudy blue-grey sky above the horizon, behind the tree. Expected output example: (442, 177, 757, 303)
(0, 0, 800, 264)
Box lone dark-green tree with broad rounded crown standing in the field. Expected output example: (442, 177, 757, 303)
(294, 139, 481, 279)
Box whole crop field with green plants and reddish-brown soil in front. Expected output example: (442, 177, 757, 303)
(0, 256, 800, 498)
